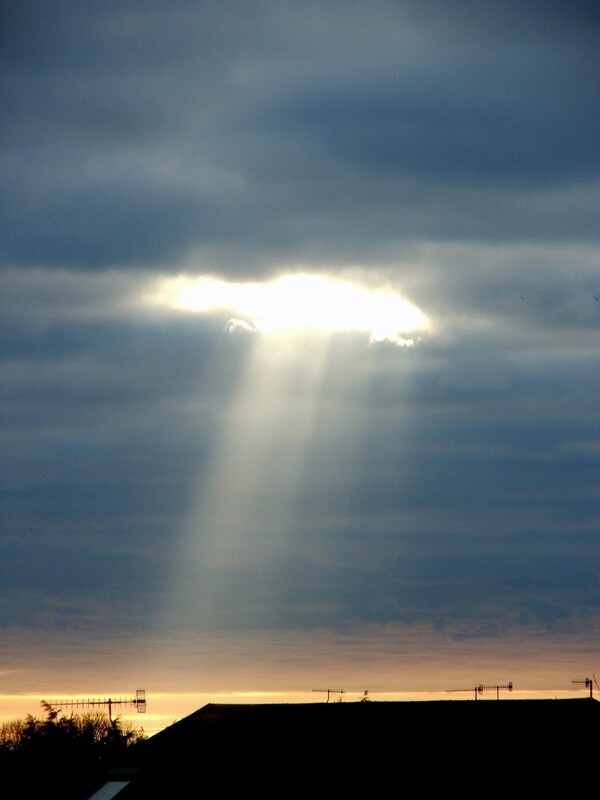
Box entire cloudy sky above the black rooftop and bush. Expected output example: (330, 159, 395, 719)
(0, 0, 600, 729)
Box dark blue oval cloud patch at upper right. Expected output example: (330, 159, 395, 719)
(280, 70, 599, 184)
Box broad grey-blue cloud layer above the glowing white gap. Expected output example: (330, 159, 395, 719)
(1, 3, 600, 272)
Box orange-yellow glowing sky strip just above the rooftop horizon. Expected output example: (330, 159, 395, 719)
(0, 625, 600, 735)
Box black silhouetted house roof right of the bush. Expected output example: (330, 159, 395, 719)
(82, 698, 600, 800)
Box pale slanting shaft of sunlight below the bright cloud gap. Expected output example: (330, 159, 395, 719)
(159, 330, 327, 628)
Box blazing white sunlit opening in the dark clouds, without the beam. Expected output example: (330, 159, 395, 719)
(154, 273, 429, 346)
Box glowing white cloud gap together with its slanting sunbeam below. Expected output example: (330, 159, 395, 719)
(153, 276, 427, 631)
